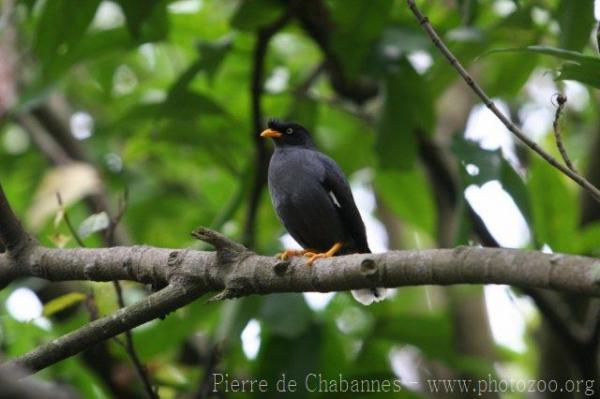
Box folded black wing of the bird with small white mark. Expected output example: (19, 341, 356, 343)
(319, 153, 371, 253)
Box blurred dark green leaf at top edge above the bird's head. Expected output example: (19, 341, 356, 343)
(231, 0, 282, 31)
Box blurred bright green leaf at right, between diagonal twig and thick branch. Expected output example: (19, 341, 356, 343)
(527, 157, 579, 252)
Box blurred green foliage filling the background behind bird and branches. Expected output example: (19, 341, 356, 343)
(0, 0, 600, 398)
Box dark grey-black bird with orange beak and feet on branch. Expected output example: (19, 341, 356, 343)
(261, 120, 383, 304)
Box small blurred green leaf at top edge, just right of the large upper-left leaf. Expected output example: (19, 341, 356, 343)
(117, 0, 169, 43)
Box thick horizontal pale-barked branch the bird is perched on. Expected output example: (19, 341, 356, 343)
(0, 241, 600, 298)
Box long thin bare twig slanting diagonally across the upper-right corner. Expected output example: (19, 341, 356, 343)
(406, 0, 600, 202)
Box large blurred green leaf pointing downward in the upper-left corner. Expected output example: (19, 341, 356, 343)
(33, 0, 100, 75)
